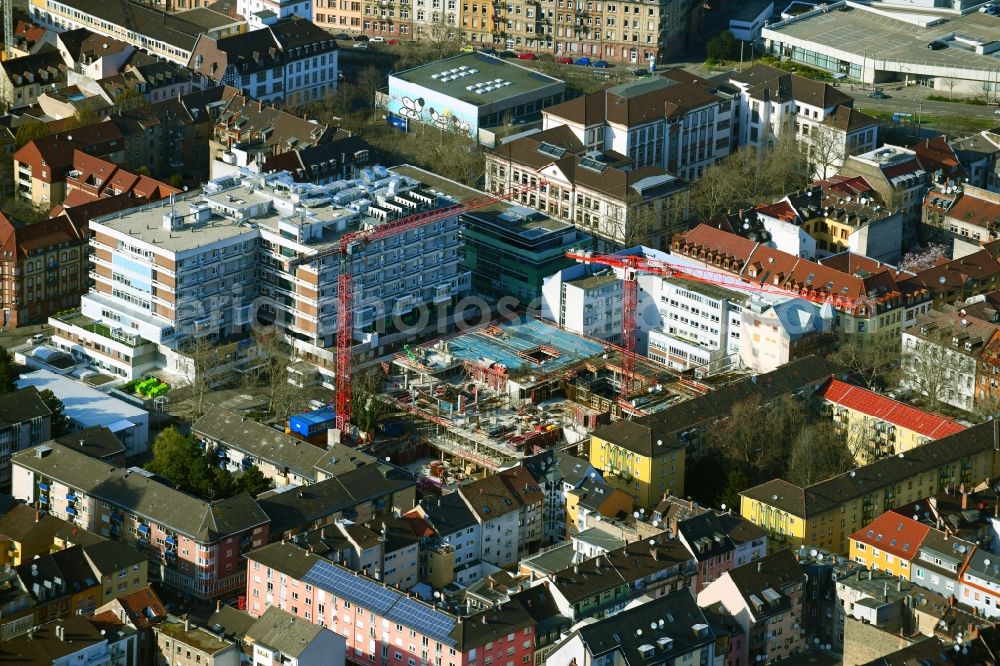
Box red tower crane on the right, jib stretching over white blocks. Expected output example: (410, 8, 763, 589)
(566, 250, 854, 402)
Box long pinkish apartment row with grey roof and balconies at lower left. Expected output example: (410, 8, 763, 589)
(11, 442, 270, 599)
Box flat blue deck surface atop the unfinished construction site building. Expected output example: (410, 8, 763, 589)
(436, 318, 605, 372)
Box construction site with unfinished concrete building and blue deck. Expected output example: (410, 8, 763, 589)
(387, 316, 703, 470)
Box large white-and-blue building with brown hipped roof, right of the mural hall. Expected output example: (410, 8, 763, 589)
(542, 70, 735, 180)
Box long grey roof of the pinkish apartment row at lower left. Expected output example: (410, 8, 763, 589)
(11, 442, 268, 542)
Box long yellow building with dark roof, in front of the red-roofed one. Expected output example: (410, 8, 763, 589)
(740, 423, 1000, 554)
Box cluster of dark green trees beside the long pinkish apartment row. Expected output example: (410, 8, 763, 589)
(146, 427, 272, 500)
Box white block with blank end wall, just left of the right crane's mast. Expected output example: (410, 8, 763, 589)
(542, 265, 623, 344)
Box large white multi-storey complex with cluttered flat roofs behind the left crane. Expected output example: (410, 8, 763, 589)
(50, 167, 471, 376)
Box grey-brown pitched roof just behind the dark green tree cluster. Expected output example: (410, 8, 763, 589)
(191, 407, 326, 479)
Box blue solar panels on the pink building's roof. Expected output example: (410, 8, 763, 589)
(302, 560, 456, 647)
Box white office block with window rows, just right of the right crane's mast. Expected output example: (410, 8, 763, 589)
(644, 278, 747, 374)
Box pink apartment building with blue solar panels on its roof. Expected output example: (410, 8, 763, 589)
(247, 543, 535, 666)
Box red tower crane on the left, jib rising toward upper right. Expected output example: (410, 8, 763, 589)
(290, 180, 548, 430)
